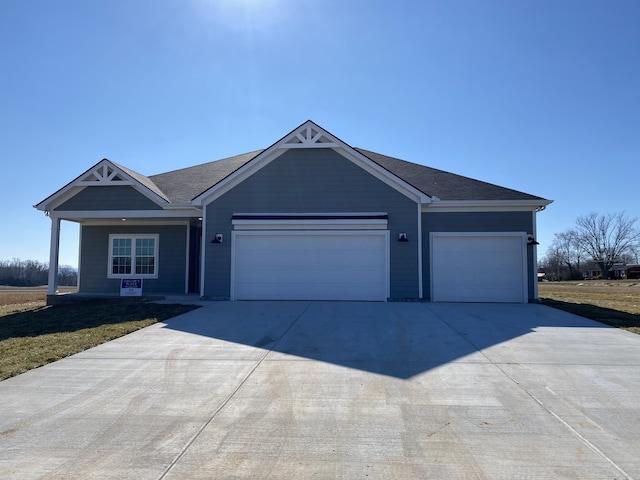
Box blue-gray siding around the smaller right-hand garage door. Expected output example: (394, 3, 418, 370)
(422, 212, 537, 300)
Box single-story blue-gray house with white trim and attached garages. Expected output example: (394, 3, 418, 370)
(35, 121, 551, 302)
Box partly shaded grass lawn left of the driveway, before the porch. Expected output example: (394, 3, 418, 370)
(0, 287, 197, 380)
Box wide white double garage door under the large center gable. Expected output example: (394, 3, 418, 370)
(231, 231, 389, 301)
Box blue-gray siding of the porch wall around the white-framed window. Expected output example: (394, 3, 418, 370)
(79, 223, 187, 295)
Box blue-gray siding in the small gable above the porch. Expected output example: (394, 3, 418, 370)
(55, 185, 162, 211)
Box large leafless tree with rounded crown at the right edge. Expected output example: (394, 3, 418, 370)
(575, 212, 640, 279)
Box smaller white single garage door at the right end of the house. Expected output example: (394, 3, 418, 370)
(431, 233, 528, 303)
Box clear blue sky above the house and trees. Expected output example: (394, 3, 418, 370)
(0, 0, 640, 266)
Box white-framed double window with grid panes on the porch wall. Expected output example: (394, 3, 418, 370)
(107, 234, 158, 278)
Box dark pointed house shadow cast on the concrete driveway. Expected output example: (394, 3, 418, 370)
(159, 302, 610, 379)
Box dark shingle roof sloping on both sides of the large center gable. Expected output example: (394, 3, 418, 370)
(135, 148, 544, 203)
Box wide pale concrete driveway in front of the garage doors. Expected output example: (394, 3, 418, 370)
(0, 302, 640, 480)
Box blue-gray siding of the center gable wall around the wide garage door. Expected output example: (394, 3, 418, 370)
(203, 148, 419, 299)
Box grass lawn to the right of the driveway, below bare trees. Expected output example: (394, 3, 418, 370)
(538, 280, 640, 334)
